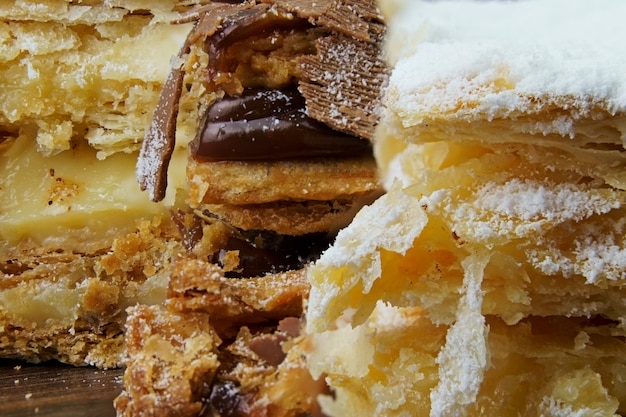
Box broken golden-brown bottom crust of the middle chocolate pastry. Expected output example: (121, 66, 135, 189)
(115, 259, 325, 417)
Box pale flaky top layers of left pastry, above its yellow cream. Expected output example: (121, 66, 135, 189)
(0, 0, 195, 158)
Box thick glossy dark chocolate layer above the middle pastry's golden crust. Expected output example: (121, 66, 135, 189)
(191, 88, 372, 162)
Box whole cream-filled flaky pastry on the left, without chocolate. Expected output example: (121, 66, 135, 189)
(0, 0, 205, 367)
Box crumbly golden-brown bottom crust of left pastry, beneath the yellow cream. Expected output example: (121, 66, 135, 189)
(0, 219, 185, 368)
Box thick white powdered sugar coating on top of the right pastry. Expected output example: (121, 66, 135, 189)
(388, 0, 626, 126)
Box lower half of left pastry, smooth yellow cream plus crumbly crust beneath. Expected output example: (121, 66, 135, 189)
(0, 135, 186, 367)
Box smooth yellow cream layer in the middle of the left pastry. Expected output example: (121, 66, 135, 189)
(0, 135, 185, 251)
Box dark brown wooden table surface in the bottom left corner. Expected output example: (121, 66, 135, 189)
(0, 360, 123, 417)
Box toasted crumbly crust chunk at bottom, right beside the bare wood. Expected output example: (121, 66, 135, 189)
(115, 305, 221, 416)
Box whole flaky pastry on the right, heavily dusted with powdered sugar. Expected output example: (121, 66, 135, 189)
(305, 0, 626, 416)
